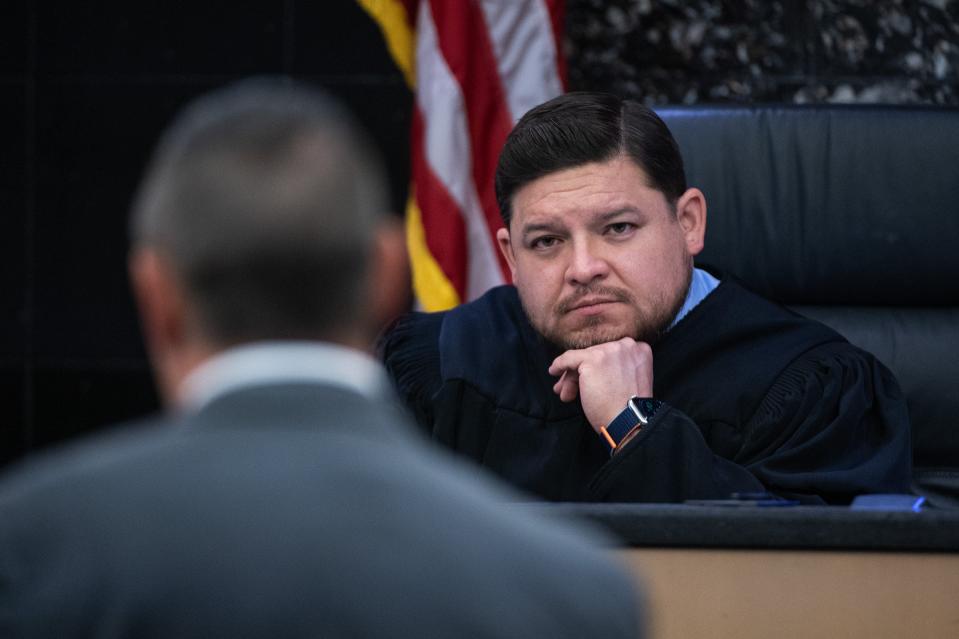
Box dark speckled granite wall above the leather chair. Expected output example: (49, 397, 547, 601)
(566, 0, 959, 105)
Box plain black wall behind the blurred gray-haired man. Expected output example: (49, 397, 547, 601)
(6, 0, 411, 464)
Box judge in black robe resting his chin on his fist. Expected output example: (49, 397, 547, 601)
(381, 93, 911, 503)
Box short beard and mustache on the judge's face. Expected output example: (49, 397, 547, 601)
(521, 268, 693, 350)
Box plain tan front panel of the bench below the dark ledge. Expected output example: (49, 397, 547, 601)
(615, 548, 959, 639)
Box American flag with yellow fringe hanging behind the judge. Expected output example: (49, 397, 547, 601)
(357, 0, 565, 311)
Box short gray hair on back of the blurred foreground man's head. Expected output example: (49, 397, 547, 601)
(131, 79, 387, 344)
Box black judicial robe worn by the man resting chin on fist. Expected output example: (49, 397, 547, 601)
(380, 279, 911, 503)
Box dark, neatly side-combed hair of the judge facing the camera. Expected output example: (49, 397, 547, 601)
(496, 92, 686, 229)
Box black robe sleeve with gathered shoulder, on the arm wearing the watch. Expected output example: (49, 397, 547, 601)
(590, 344, 911, 503)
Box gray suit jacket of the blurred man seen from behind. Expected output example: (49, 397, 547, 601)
(0, 383, 640, 639)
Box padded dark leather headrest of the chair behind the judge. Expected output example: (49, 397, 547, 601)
(658, 105, 959, 306)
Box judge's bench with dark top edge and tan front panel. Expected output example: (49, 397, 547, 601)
(524, 504, 959, 639)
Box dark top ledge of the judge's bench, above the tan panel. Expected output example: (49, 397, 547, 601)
(529, 503, 959, 552)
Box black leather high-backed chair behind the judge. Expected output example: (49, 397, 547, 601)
(657, 105, 959, 507)
